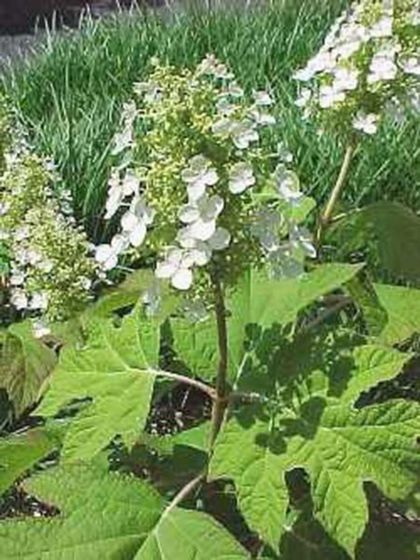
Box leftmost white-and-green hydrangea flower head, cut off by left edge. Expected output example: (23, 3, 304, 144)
(0, 102, 96, 328)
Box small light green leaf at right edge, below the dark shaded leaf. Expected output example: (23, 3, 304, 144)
(375, 284, 420, 344)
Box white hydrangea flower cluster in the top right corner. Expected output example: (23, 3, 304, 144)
(294, 0, 420, 135)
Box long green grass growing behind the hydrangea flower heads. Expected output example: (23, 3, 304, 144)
(2, 0, 420, 240)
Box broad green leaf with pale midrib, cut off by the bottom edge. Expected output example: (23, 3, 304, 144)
(0, 465, 249, 560)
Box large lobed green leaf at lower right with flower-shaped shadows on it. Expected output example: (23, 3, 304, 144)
(210, 333, 420, 555)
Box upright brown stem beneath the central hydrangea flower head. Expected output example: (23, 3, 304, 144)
(209, 274, 229, 453)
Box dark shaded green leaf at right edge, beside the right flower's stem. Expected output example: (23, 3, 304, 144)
(333, 201, 420, 282)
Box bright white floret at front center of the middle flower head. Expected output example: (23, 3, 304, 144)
(179, 194, 224, 241)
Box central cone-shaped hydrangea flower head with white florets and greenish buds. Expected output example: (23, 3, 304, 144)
(96, 55, 315, 300)
